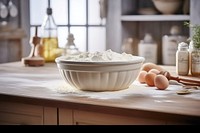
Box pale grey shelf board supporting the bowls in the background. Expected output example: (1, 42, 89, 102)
(121, 15, 190, 21)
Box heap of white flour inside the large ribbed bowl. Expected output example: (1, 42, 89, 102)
(59, 49, 139, 62)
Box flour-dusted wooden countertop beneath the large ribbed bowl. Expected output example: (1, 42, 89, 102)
(0, 62, 200, 122)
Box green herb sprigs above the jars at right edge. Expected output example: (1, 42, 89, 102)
(184, 22, 200, 49)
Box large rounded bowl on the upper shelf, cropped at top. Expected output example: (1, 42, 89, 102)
(152, 0, 182, 14)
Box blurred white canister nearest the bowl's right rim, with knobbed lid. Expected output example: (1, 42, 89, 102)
(138, 33, 157, 64)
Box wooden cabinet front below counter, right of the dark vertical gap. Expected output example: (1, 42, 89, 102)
(58, 108, 198, 125)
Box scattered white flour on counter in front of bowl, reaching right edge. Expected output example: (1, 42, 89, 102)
(56, 81, 200, 102)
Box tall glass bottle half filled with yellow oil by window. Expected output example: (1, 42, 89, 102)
(41, 1, 58, 62)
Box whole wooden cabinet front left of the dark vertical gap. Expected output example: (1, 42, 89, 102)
(0, 102, 57, 125)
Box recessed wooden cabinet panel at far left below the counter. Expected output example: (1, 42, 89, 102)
(0, 102, 43, 125)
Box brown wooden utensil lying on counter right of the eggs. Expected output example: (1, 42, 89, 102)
(160, 71, 200, 86)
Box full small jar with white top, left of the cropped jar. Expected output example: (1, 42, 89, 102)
(176, 42, 189, 75)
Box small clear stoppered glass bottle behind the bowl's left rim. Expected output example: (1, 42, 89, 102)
(65, 33, 79, 55)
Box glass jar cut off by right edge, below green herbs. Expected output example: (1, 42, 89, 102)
(190, 41, 200, 77)
